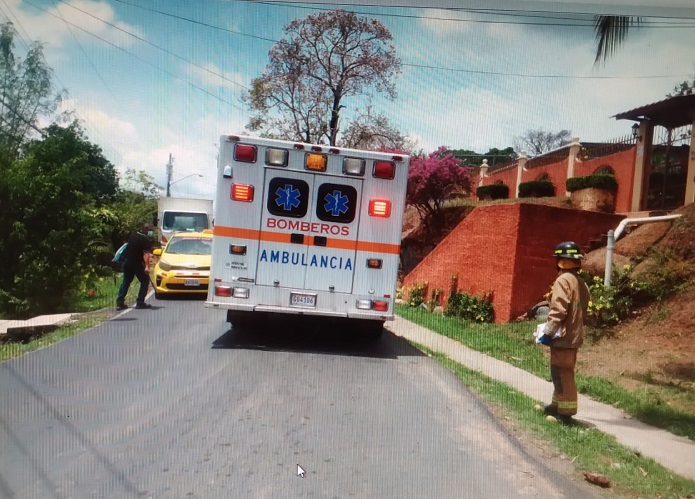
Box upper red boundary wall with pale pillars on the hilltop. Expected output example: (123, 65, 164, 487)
(476, 147, 636, 213)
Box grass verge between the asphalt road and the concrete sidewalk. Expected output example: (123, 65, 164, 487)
(422, 345, 695, 498)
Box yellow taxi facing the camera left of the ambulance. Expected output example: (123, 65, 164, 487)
(152, 230, 212, 298)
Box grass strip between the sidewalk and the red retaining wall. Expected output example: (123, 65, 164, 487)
(396, 305, 695, 440)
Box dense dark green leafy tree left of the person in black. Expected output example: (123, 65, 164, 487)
(0, 124, 112, 315)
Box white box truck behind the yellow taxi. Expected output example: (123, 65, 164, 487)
(157, 197, 212, 245)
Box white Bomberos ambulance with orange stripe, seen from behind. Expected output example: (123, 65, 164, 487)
(205, 135, 410, 336)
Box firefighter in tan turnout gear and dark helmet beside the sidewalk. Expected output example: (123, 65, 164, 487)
(538, 241, 590, 424)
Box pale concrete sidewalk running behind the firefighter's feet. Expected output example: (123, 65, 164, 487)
(386, 317, 695, 480)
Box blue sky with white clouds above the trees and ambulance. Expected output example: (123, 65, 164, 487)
(0, 0, 695, 198)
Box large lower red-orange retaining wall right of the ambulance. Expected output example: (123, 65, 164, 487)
(403, 203, 623, 323)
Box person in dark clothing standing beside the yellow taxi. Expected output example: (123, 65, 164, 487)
(116, 224, 154, 310)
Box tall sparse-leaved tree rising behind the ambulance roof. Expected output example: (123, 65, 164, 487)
(243, 10, 400, 145)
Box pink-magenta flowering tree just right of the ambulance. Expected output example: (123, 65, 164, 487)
(405, 146, 473, 225)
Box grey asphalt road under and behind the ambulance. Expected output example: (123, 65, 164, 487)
(0, 300, 586, 499)
